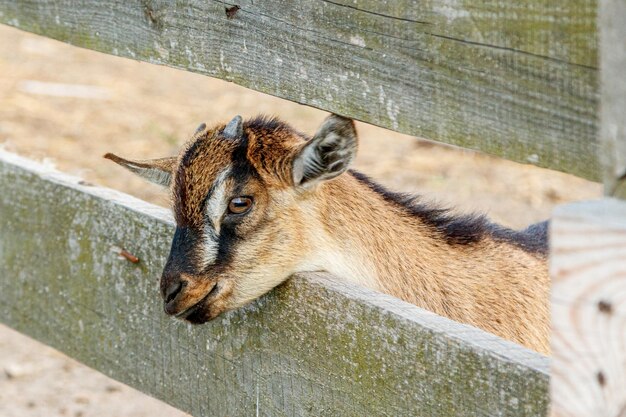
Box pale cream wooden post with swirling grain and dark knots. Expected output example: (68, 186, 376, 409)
(551, 199, 626, 417)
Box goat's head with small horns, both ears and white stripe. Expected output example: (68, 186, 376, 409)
(105, 115, 357, 323)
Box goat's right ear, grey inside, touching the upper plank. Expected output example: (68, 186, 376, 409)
(292, 114, 358, 187)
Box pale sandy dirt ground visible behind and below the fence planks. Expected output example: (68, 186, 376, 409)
(0, 26, 601, 417)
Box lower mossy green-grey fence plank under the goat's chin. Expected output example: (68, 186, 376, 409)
(0, 153, 548, 417)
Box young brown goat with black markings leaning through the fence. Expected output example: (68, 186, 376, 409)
(105, 115, 550, 353)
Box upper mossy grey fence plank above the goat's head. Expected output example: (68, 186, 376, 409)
(0, 0, 602, 180)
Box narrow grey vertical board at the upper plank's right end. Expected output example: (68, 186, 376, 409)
(599, 0, 626, 198)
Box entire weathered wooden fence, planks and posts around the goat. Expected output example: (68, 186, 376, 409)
(0, 0, 626, 417)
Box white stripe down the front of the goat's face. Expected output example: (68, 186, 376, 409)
(203, 167, 230, 268)
